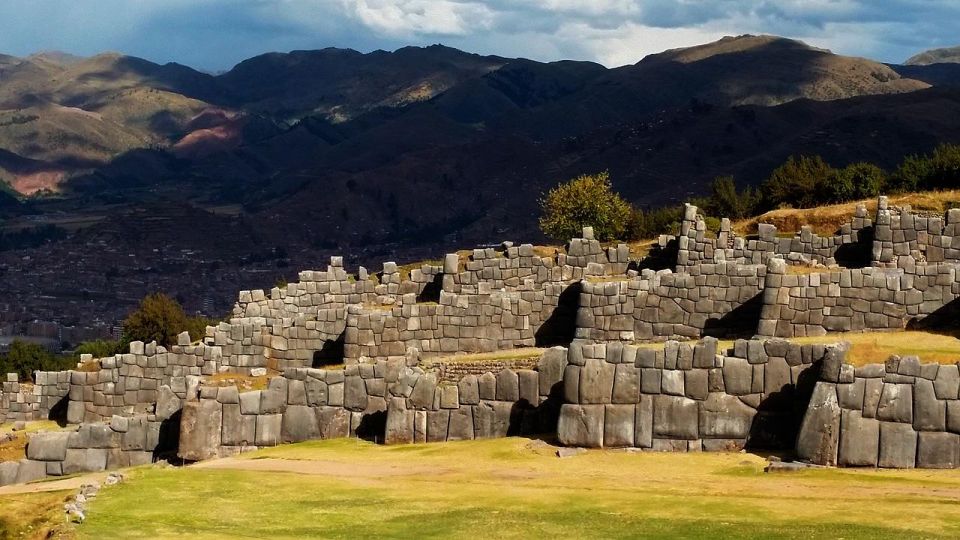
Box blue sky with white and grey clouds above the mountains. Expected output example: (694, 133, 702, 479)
(0, 0, 960, 71)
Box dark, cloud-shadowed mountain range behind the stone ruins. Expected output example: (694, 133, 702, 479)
(0, 35, 960, 326)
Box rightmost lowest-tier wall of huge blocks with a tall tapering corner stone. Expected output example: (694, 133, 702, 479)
(796, 352, 960, 468)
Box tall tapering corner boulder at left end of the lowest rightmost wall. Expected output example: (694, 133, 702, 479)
(797, 382, 840, 465)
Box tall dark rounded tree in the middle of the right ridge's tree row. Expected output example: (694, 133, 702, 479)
(760, 156, 836, 208)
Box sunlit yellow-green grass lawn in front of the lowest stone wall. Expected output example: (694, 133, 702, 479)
(63, 438, 960, 539)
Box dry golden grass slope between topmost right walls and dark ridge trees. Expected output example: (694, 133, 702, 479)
(733, 190, 960, 235)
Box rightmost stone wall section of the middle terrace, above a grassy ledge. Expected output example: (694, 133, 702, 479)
(757, 259, 960, 337)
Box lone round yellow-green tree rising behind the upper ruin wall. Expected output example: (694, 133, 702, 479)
(540, 172, 632, 241)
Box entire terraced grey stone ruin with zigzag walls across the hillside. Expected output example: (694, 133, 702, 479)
(0, 197, 960, 484)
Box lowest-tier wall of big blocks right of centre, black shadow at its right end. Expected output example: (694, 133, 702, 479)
(557, 338, 826, 451)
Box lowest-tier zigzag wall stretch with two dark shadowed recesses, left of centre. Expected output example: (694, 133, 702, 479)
(179, 347, 566, 460)
